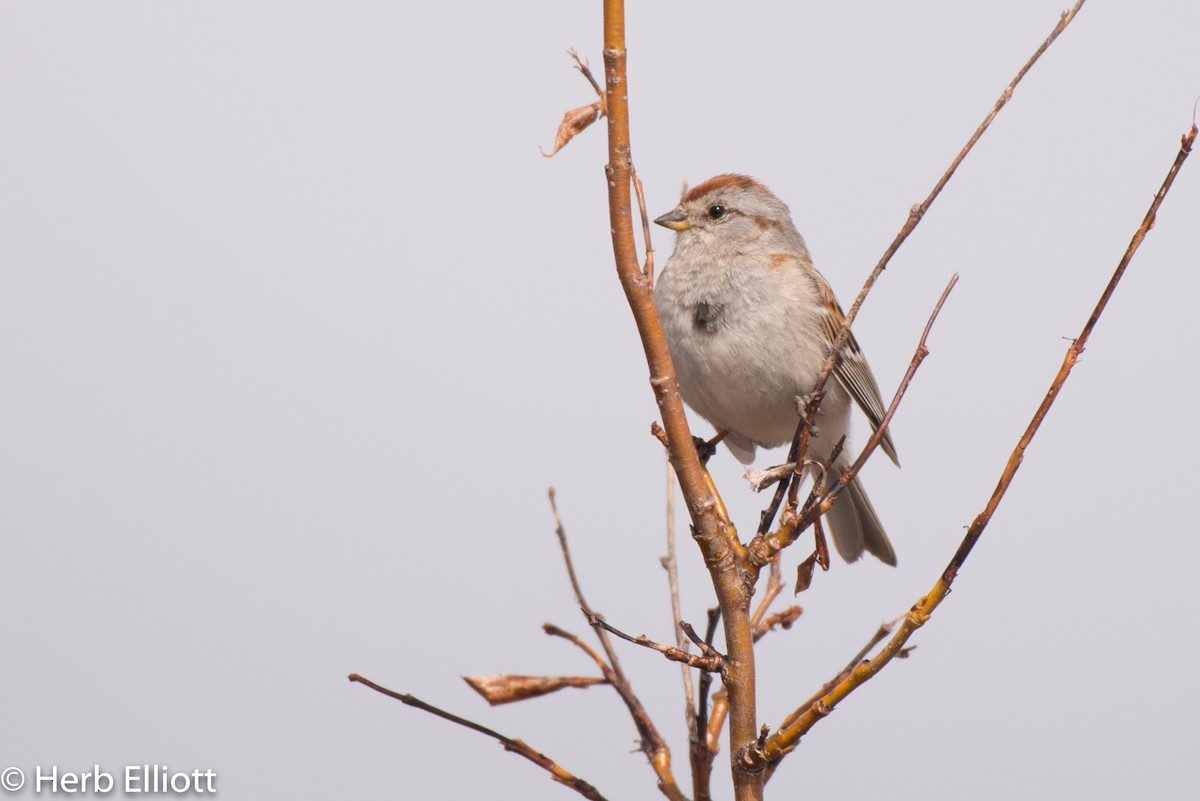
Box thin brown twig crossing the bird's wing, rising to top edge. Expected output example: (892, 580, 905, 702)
(758, 0, 1085, 535)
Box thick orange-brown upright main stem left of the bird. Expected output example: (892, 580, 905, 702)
(604, 0, 762, 801)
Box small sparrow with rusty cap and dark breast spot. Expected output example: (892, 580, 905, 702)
(654, 174, 900, 565)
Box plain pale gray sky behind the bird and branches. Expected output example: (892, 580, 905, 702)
(0, 0, 1200, 800)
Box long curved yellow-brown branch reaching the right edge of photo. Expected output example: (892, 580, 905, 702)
(763, 125, 1196, 761)
